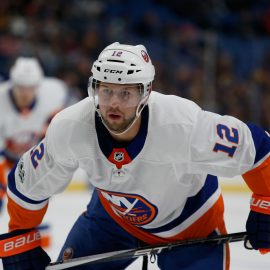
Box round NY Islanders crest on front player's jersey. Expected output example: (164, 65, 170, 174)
(98, 189, 158, 226)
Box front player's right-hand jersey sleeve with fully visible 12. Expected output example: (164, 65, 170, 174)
(190, 108, 270, 195)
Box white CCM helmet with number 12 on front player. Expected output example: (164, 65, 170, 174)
(88, 42, 155, 99)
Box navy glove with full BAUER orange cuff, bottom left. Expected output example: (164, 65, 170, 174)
(0, 230, 51, 270)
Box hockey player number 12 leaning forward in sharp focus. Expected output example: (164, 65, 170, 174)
(0, 43, 270, 270)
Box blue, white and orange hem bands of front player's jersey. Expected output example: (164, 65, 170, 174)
(97, 175, 225, 244)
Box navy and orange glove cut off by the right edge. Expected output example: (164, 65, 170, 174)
(245, 194, 270, 254)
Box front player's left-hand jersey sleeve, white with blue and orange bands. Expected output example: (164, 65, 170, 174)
(7, 119, 77, 231)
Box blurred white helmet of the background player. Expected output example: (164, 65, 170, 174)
(10, 57, 43, 87)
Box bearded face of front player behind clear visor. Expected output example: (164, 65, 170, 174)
(96, 83, 141, 132)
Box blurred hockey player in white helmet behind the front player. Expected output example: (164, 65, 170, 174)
(0, 57, 67, 214)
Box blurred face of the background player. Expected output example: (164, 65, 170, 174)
(13, 86, 36, 108)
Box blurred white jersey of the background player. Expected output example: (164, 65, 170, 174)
(0, 78, 67, 162)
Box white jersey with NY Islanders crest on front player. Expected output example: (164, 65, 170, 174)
(8, 92, 269, 243)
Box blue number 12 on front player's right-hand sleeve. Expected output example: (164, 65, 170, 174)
(213, 124, 239, 157)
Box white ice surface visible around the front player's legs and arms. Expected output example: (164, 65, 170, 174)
(0, 185, 270, 270)
